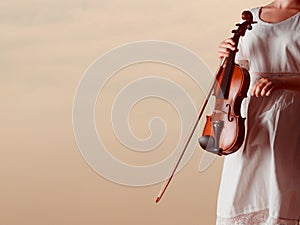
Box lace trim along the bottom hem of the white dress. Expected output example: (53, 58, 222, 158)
(217, 209, 300, 225)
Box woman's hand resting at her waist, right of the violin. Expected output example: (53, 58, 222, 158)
(251, 78, 283, 97)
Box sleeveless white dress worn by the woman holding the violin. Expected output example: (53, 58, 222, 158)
(217, 8, 300, 225)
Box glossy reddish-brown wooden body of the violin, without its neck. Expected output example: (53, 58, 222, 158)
(199, 64, 250, 155)
